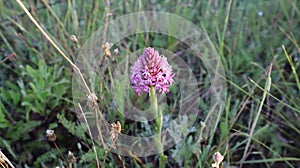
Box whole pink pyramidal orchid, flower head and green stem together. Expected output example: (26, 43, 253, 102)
(130, 47, 174, 168)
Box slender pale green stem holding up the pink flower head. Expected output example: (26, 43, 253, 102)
(150, 86, 167, 168)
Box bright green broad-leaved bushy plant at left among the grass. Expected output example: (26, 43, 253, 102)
(18, 61, 70, 119)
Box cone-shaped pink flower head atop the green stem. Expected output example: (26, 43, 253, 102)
(130, 47, 174, 96)
